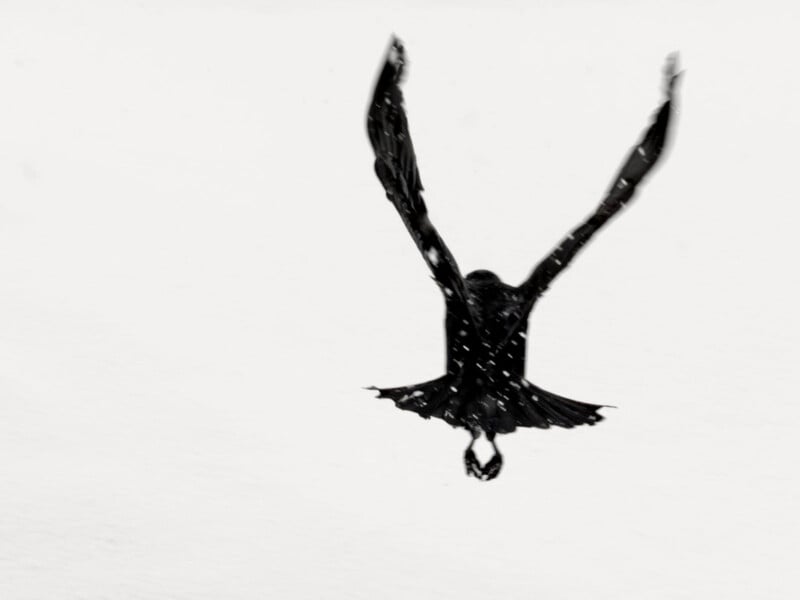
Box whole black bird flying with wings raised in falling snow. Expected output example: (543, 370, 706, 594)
(366, 36, 680, 481)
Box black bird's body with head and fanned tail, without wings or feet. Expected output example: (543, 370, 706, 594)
(379, 271, 603, 439)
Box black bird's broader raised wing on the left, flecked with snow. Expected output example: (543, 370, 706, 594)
(367, 38, 474, 330)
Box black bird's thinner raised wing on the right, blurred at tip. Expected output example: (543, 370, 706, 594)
(520, 55, 678, 308)
